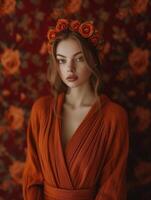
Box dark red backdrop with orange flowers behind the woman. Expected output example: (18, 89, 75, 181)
(0, 0, 151, 200)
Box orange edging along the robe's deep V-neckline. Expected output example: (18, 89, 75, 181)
(57, 93, 98, 154)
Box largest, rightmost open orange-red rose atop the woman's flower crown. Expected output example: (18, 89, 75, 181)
(79, 22, 94, 38)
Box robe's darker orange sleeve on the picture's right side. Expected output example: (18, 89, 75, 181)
(95, 103, 129, 200)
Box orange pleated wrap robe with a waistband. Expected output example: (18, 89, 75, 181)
(23, 93, 129, 200)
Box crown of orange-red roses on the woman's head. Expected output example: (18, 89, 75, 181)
(47, 18, 104, 52)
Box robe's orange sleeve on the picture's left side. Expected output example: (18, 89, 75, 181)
(23, 100, 43, 200)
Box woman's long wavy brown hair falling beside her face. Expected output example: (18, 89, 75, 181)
(47, 30, 102, 113)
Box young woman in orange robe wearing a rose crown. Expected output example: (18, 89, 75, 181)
(23, 19, 129, 200)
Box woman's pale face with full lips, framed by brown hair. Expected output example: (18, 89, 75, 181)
(56, 38, 92, 88)
